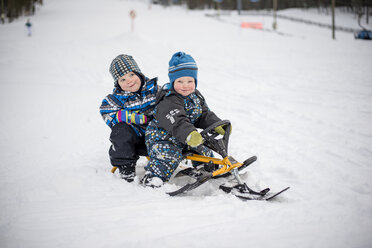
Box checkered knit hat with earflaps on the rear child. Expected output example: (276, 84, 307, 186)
(110, 54, 142, 85)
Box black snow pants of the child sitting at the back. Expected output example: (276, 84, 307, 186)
(109, 122, 147, 169)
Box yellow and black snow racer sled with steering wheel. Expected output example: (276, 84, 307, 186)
(111, 120, 289, 200)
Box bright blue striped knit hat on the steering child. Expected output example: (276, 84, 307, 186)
(168, 52, 198, 88)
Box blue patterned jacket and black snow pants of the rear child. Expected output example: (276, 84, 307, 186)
(100, 77, 158, 169)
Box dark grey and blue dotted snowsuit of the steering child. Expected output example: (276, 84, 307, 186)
(145, 84, 220, 181)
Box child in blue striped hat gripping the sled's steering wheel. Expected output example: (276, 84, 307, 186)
(141, 52, 225, 187)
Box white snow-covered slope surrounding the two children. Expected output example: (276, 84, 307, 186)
(0, 0, 372, 248)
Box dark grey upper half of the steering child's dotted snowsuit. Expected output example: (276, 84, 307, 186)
(146, 83, 221, 144)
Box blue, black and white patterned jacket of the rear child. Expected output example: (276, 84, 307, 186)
(100, 78, 158, 136)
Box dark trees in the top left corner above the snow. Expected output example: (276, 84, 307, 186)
(0, 0, 43, 23)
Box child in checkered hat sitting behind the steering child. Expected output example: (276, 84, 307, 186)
(100, 54, 158, 182)
